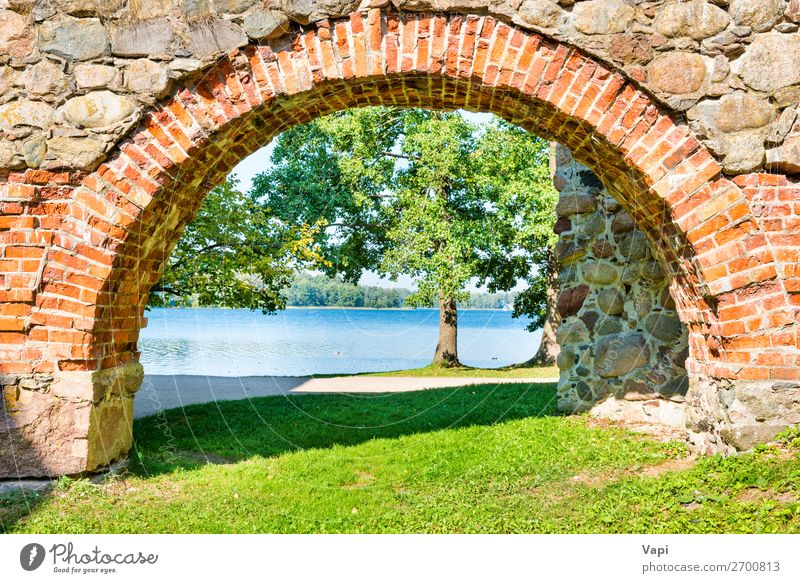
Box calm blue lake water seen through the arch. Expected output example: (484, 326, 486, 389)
(139, 308, 541, 376)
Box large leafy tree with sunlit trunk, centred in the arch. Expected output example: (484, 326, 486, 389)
(254, 108, 553, 366)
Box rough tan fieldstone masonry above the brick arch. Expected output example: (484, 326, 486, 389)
(0, 0, 800, 174)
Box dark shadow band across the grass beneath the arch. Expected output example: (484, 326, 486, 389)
(130, 383, 557, 476)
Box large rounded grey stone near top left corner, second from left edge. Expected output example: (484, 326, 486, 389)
(39, 17, 108, 61)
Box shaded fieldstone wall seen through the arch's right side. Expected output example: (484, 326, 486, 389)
(554, 145, 689, 427)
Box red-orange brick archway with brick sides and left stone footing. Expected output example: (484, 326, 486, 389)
(0, 10, 800, 475)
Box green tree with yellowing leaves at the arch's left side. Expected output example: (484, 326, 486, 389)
(150, 178, 324, 312)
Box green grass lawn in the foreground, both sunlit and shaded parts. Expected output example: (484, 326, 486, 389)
(0, 384, 800, 533)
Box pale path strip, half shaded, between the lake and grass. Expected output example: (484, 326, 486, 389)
(134, 375, 558, 417)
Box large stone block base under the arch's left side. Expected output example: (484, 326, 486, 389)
(0, 362, 143, 478)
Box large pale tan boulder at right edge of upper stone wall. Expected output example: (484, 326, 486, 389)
(732, 32, 800, 92)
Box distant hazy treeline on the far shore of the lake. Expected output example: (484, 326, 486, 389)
(285, 274, 515, 309)
